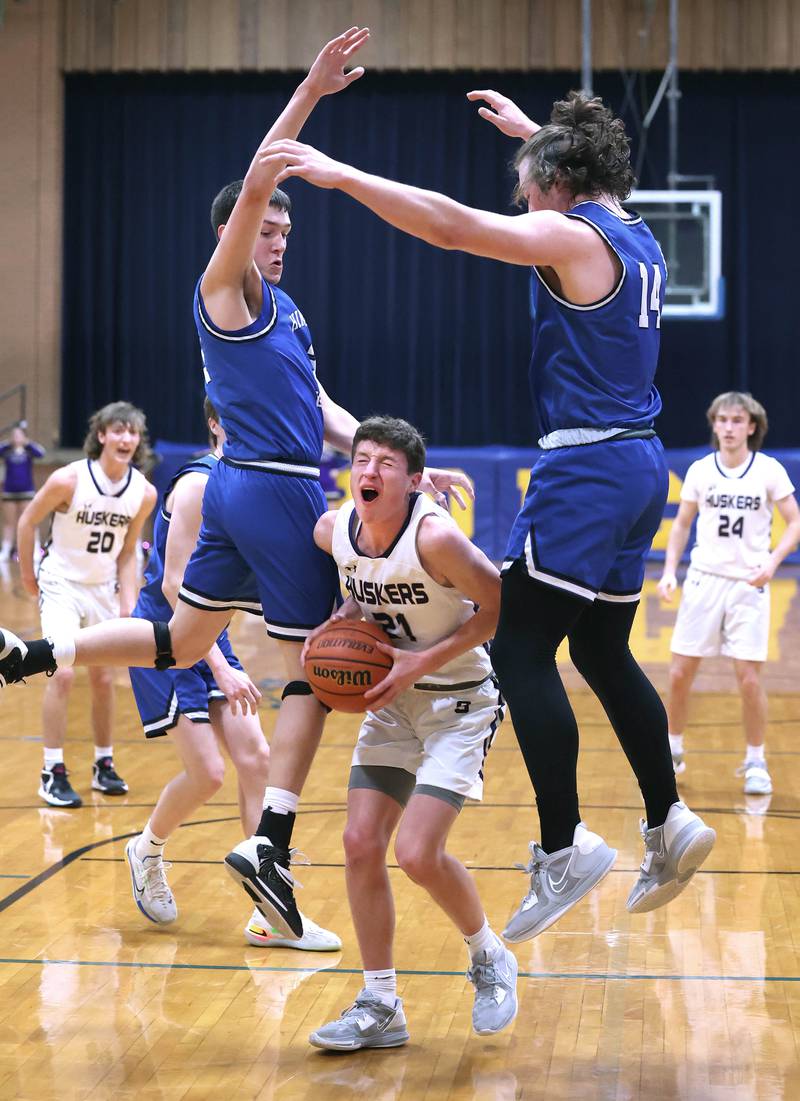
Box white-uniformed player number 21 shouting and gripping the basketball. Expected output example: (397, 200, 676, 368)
(304, 416, 517, 1051)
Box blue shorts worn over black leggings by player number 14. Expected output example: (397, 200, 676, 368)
(503, 437, 669, 601)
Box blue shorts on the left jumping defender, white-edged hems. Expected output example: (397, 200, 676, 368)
(179, 461, 339, 642)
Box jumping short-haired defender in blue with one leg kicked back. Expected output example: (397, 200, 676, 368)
(0, 28, 471, 937)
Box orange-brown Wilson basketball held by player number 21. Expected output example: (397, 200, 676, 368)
(306, 620, 393, 715)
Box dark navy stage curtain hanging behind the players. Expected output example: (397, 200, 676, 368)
(62, 73, 800, 447)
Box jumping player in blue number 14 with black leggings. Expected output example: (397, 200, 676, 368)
(265, 85, 715, 940)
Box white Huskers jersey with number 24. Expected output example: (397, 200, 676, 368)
(680, 451, 794, 580)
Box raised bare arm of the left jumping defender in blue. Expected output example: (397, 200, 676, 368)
(202, 26, 370, 306)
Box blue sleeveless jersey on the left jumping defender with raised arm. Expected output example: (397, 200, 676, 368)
(194, 279, 322, 466)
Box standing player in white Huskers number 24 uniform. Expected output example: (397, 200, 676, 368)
(658, 391, 800, 796)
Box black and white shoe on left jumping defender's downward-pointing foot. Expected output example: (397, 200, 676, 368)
(224, 837, 303, 937)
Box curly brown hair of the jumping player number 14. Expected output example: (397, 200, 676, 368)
(513, 91, 636, 203)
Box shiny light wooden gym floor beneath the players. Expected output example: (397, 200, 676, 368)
(0, 567, 800, 1101)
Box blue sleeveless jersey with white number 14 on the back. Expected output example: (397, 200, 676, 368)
(530, 200, 667, 435)
